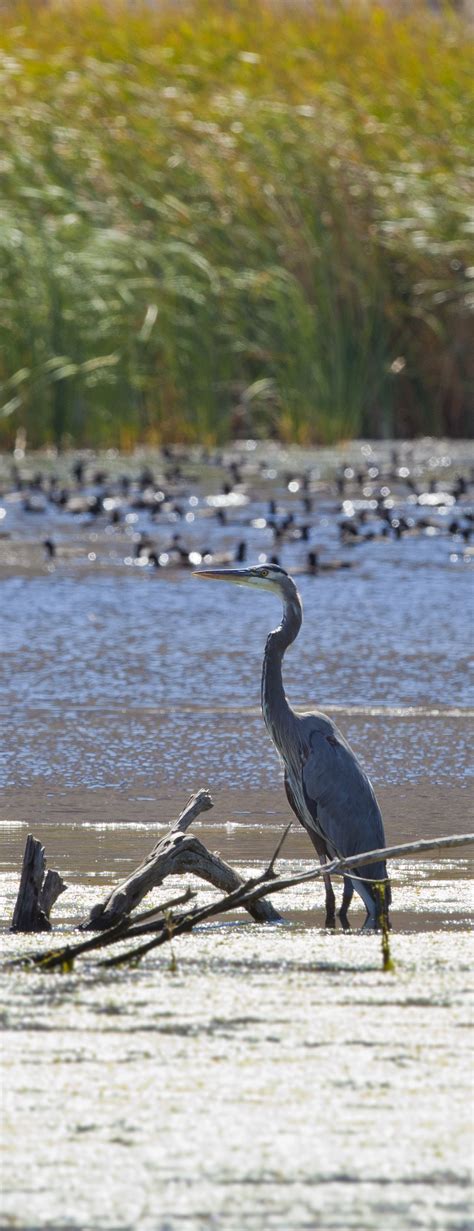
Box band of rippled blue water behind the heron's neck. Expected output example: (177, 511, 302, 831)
(1, 560, 473, 787)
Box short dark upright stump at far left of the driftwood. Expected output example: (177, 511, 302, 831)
(10, 833, 68, 932)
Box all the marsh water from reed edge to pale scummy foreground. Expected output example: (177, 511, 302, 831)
(0, 441, 474, 1231)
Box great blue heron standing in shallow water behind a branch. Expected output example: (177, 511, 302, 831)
(195, 564, 390, 928)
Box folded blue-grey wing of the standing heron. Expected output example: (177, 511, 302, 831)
(303, 715, 385, 876)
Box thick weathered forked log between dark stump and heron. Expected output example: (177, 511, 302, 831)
(80, 790, 281, 931)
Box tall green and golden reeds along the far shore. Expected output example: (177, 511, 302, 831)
(0, 0, 474, 448)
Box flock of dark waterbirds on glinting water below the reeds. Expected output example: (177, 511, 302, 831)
(0, 447, 474, 576)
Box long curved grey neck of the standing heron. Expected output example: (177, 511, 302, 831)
(262, 593, 303, 752)
